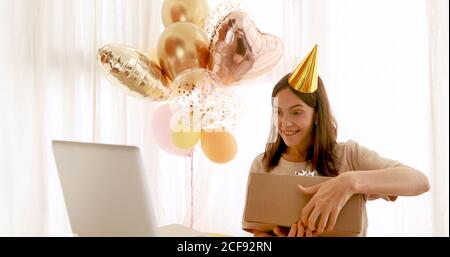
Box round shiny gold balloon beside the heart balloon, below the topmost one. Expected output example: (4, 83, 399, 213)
(158, 22, 209, 80)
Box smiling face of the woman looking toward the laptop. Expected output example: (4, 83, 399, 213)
(273, 88, 315, 149)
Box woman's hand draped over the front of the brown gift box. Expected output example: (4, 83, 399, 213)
(298, 174, 354, 235)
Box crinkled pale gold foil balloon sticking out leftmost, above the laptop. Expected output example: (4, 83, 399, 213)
(97, 45, 169, 101)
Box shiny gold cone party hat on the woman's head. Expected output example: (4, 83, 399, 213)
(288, 44, 317, 93)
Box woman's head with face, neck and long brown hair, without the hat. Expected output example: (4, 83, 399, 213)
(263, 73, 339, 176)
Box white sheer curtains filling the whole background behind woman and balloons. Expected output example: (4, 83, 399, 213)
(0, 0, 448, 236)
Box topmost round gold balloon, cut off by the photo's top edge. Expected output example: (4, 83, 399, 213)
(161, 0, 209, 27)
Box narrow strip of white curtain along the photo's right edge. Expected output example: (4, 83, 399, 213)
(428, 0, 449, 236)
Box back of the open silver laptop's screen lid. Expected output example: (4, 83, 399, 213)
(52, 141, 157, 237)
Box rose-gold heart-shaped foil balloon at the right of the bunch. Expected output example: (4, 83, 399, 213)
(208, 11, 283, 84)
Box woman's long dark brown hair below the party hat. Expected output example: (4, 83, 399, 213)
(263, 74, 338, 176)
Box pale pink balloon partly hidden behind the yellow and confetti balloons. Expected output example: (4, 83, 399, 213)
(152, 104, 192, 157)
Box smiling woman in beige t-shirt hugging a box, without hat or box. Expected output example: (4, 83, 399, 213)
(243, 74, 429, 237)
